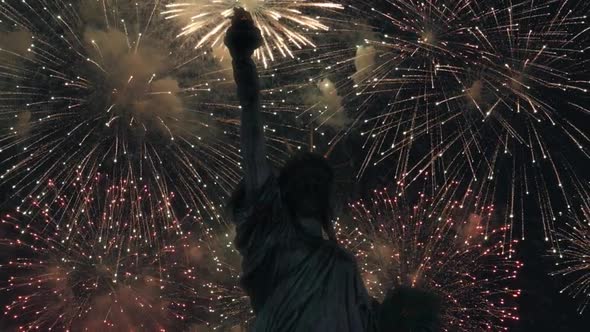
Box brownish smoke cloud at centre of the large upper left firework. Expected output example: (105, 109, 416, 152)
(84, 29, 183, 129)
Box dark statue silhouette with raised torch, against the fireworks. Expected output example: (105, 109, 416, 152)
(225, 8, 440, 332)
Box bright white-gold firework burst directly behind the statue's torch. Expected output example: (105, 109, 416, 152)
(163, 0, 344, 66)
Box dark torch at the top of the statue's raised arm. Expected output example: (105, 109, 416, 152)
(225, 8, 262, 59)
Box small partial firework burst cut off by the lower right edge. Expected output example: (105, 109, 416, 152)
(552, 206, 590, 315)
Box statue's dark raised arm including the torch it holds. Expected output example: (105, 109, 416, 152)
(225, 8, 271, 200)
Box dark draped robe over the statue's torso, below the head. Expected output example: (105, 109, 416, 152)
(234, 176, 375, 332)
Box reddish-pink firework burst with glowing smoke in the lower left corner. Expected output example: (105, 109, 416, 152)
(0, 175, 213, 331)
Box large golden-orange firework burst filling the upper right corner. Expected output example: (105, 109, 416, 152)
(304, 0, 590, 241)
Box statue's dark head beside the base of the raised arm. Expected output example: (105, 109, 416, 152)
(279, 152, 334, 238)
